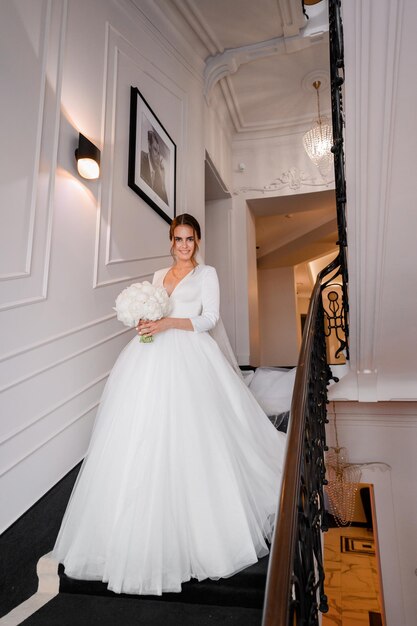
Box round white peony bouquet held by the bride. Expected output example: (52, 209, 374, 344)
(114, 280, 170, 343)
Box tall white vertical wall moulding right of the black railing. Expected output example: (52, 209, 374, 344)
(345, 0, 403, 401)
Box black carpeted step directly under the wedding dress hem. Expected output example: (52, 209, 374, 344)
(58, 556, 268, 608)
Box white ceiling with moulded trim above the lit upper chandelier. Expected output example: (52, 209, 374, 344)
(153, 0, 330, 132)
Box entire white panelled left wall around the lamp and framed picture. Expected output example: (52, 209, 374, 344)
(0, 0, 218, 532)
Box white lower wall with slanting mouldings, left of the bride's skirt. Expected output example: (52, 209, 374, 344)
(0, 315, 133, 532)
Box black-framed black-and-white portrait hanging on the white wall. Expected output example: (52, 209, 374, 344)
(128, 87, 177, 224)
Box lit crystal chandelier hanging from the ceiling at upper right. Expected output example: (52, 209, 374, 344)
(303, 80, 333, 176)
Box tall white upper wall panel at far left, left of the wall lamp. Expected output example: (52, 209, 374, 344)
(0, 0, 66, 310)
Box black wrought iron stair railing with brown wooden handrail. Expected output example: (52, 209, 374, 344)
(262, 0, 349, 626)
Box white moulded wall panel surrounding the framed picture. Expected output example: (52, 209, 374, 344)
(95, 25, 188, 286)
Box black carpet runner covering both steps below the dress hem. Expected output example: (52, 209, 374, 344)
(22, 557, 268, 626)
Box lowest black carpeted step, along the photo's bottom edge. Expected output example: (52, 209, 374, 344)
(22, 593, 262, 626)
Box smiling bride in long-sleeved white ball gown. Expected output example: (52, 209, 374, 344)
(54, 214, 285, 594)
